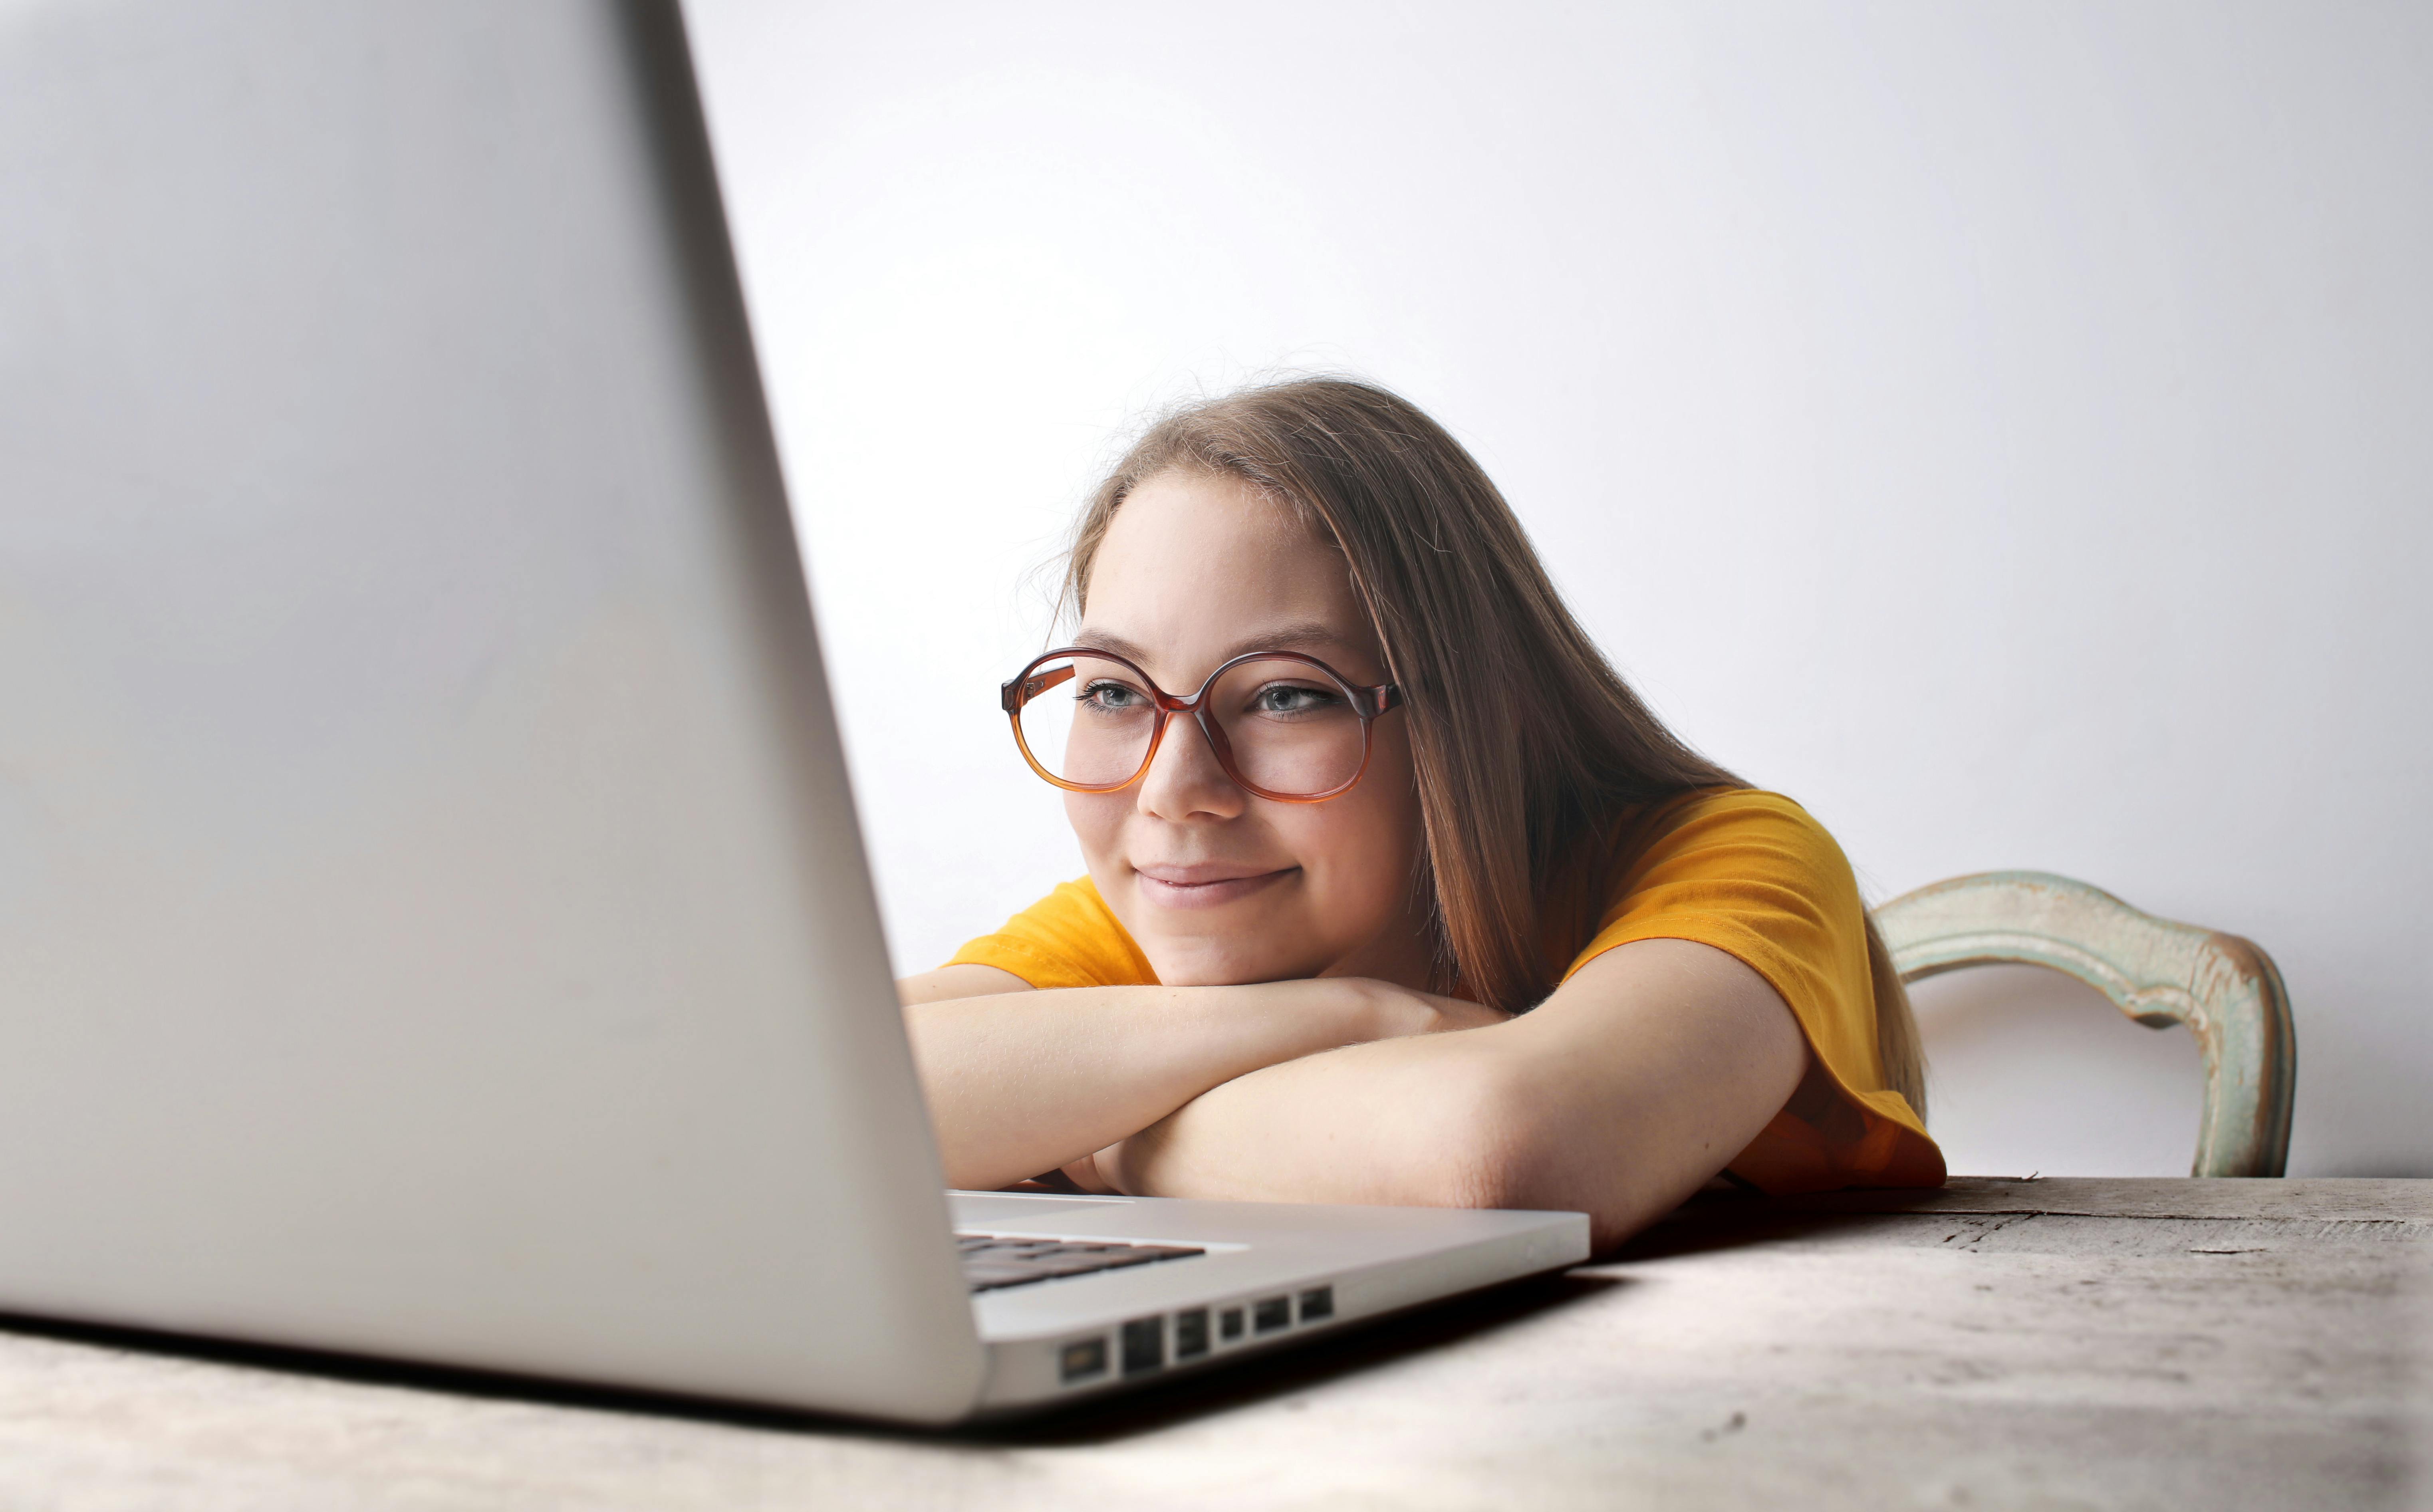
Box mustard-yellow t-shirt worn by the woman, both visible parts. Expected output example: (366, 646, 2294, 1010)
(949, 789, 1944, 1193)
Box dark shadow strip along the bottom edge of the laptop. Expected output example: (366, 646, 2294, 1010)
(0, 1276, 1630, 1446)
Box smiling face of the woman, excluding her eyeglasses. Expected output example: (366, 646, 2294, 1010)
(1066, 470, 1431, 986)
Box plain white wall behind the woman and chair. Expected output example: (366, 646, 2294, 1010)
(691, 0, 2433, 1174)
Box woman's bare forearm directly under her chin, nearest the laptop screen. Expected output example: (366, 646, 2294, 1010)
(898, 966, 1496, 1188)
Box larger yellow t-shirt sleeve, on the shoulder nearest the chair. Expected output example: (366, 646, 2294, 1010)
(1564, 791, 1944, 1193)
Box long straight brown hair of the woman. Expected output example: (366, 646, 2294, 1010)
(1066, 377, 1925, 1115)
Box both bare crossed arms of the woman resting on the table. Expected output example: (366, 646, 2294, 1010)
(900, 940, 1808, 1249)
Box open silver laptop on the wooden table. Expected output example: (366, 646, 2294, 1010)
(0, 0, 1589, 1425)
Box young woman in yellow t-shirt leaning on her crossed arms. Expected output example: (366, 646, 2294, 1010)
(903, 380, 1944, 1246)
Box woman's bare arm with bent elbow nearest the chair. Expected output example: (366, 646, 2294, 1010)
(1095, 940, 1808, 1249)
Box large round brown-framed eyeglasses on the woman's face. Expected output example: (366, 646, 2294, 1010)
(1000, 645, 1401, 804)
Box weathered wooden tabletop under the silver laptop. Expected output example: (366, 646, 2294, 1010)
(0, 1181, 2433, 1512)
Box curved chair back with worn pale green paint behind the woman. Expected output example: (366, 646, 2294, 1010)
(1876, 872, 2297, 1176)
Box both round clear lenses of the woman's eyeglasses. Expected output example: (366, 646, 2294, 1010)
(1020, 655, 1365, 796)
